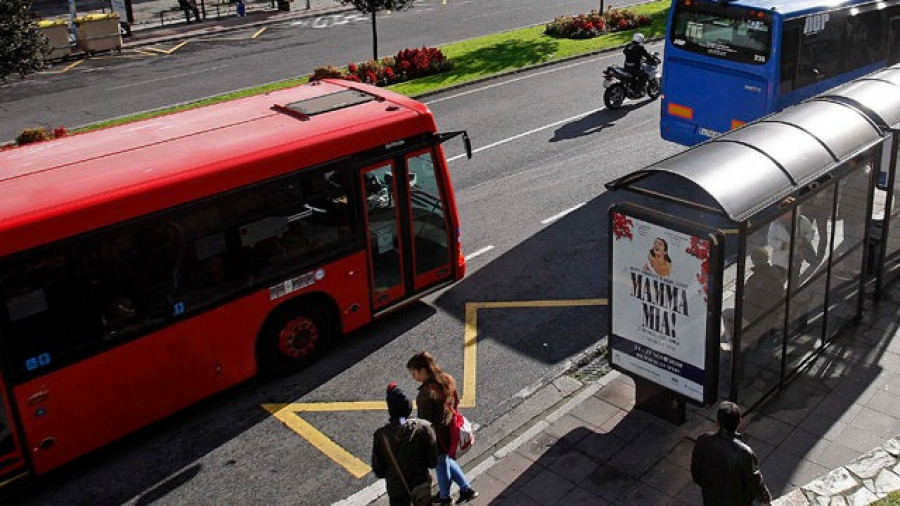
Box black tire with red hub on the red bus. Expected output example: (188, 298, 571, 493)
(256, 300, 335, 376)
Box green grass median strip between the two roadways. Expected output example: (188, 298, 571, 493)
(69, 0, 671, 135)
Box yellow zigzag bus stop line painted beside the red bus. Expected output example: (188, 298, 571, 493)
(262, 299, 608, 478)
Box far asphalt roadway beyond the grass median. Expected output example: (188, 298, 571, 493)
(0, 0, 637, 141)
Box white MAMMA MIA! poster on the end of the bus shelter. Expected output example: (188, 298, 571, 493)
(609, 209, 711, 403)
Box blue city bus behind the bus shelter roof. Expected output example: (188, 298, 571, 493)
(659, 0, 900, 146)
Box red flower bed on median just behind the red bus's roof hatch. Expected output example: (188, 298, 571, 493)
(310, 47, 453, 86)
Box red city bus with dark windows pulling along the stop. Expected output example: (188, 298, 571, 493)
(0, 80, 471, 485)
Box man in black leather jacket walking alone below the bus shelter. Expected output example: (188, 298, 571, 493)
(691, 401, 772, 506)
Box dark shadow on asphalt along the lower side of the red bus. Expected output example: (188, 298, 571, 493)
(12, 302, 435, 506)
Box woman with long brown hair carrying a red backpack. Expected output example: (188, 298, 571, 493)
(406, 351, 478, 504)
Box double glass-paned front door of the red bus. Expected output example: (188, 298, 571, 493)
(362, 150, 454, 311)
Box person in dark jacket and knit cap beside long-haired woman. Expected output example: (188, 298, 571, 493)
(372, 383, 437, 506)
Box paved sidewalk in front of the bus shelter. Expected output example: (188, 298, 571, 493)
(364, 285, 900, 506)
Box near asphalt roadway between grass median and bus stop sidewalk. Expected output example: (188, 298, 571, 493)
(8, 39, 680, 505)
